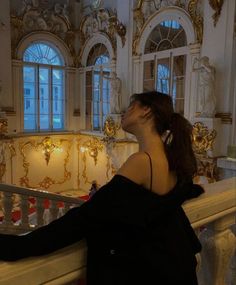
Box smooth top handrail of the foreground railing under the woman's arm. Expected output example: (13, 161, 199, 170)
(0, 177, 236, 285)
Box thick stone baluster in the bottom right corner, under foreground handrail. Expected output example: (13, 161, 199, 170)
(205, 213, 236, 285)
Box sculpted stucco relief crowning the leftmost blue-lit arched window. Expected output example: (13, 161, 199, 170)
(11, 0, 76, 63)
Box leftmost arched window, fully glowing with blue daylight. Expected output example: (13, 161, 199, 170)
(23, 42, 65, 131)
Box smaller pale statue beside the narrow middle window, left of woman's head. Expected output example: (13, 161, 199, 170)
(103, 71, 121, 114)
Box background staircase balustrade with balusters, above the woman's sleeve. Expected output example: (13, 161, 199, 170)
(0, 183, 84, 233)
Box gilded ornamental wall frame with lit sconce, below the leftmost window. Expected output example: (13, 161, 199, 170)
(19, 137, 72, 189)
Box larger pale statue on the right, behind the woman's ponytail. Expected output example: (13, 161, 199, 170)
(193, 56, 216, 118)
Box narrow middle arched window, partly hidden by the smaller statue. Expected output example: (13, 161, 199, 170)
(86, 44, 110, 131)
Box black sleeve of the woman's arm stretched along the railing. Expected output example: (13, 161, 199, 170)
(0, 182, 112, 261)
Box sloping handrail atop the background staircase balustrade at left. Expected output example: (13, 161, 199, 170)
(0, 183, 84, 206)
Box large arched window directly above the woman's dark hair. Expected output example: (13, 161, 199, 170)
(143, 20, 187, 114)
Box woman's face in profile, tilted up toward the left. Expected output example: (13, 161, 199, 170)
(121, 101, 144, 134)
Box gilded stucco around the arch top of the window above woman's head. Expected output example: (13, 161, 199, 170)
(132, 0, 203, 55)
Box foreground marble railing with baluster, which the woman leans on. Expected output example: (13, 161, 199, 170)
(0, 177, 236, 285)
